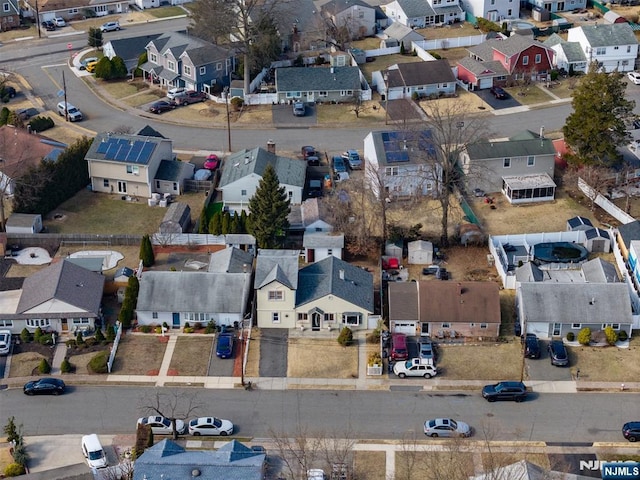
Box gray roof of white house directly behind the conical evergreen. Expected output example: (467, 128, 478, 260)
(219, 147, 307, 187)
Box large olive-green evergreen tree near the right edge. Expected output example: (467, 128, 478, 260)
(562, 62, 635, 166)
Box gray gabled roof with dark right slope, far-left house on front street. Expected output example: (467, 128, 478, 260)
(17, 261, 104, 316)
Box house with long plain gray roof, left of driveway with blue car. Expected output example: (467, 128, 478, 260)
(136, 248, 253, 328)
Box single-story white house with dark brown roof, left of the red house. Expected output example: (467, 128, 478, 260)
(372, 60, 456, 100)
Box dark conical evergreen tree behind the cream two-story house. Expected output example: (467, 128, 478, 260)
(249, 164, 290, 248)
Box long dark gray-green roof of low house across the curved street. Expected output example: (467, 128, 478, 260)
(276, 67, 361, 93)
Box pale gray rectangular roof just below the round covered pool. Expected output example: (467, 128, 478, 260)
(520, 282, 632, 325)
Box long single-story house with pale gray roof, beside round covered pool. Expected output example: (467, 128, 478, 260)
(516, 282, 633, 340)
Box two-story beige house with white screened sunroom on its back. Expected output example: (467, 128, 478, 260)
(460, 132, 556, 204)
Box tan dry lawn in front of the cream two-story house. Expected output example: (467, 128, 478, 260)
(287, 333, 358, 378)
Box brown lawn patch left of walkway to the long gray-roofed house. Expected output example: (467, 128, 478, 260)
(113, 334, 167, 375)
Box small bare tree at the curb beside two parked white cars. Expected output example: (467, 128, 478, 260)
(139, 388, 205, 440)
